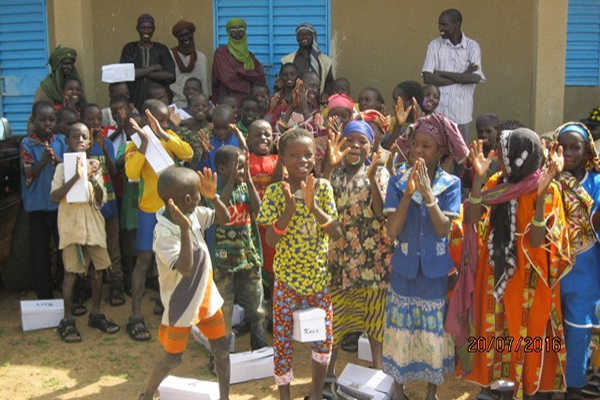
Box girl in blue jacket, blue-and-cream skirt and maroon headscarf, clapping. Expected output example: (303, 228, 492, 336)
(383, 114, 469, 400)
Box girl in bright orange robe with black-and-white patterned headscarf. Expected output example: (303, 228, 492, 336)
(446, 128, 571, 399)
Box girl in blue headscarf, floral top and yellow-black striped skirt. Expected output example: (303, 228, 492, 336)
(324, 121, 392, 384)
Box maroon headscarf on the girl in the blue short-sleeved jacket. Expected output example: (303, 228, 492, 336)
(413, 113, 469, 163)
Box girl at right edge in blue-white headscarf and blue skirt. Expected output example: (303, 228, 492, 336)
(555, 122, 600, 399)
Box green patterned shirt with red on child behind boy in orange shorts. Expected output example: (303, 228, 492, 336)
(214, 183, 262, 272)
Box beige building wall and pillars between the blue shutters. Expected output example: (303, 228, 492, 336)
(49, 0, 570, 130)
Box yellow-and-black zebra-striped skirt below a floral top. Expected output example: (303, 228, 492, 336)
(331, 288, 387, 344)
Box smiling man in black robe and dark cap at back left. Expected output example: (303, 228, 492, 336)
(120, 14, 175, 110)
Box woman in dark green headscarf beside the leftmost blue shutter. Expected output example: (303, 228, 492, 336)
(34, 45, 80, 106)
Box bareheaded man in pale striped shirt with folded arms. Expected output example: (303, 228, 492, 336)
(422, 8, 485, 143)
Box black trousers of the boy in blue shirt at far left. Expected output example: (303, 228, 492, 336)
(29, 211, 58, 299)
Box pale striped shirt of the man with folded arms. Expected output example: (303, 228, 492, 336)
(422, 33, 485, 125)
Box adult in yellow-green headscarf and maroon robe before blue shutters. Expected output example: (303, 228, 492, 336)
(212, 18, 266, 105)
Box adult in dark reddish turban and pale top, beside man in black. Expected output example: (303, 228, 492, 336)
(170, 20, 210, 107)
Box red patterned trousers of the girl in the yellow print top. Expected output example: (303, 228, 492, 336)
(273, 279, 333, 386)
